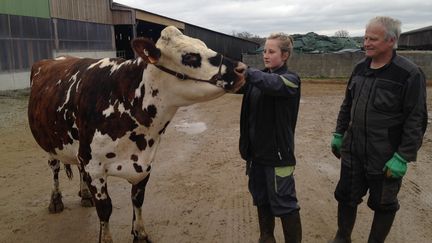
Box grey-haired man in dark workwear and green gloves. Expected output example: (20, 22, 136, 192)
(331, 17, 427, 243)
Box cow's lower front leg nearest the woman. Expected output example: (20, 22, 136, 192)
(131, 174, 150, 243)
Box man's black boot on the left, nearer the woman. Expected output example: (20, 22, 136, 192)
(330, 203, 357, 243)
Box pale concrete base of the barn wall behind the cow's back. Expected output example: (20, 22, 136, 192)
(0, 51, 116, 90)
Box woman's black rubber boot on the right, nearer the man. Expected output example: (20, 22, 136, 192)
(281, 211, 302, 243)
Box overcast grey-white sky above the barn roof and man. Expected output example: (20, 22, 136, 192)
(114, 0, 432, 37)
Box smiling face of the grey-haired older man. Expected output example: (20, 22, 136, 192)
(363, 24, 395, 59)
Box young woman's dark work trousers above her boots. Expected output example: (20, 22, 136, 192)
(247, 162, 300, 217)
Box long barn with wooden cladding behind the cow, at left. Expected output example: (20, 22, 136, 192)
(0, 0, 259, 90)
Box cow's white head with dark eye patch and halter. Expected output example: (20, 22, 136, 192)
(132, 26, 246, 98)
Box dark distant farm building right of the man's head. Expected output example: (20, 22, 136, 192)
(398, 26, 432, 50)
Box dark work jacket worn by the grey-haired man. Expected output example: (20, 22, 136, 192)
(336, 52, 427, 174)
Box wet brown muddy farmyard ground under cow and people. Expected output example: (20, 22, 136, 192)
(0, 82, 432, 243)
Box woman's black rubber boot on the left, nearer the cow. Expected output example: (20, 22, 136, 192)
(257, 205, 276, 243)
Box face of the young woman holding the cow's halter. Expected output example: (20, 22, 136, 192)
(263, 39, 288, 70)
